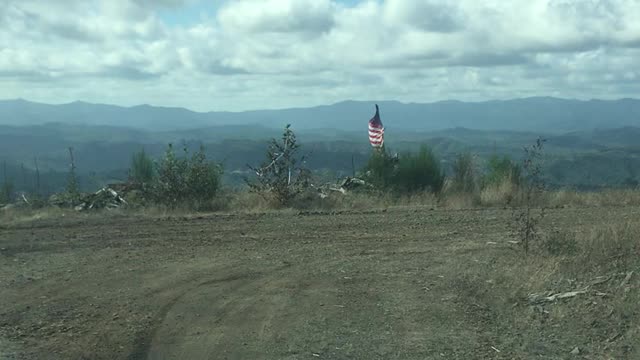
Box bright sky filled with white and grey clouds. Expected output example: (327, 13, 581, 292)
(0, 0, 640, 111)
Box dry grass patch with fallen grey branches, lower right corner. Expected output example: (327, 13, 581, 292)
(450, 221, 640, 359)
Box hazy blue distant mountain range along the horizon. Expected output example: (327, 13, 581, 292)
(0, 97, 640, 133)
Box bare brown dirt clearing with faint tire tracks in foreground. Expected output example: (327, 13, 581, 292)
(0, 207, 640, 359)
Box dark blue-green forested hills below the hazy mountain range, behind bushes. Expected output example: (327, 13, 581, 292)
(0, 124, 640, 192)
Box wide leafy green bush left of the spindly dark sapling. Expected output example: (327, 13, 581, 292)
(153, 144, 222, 210)
